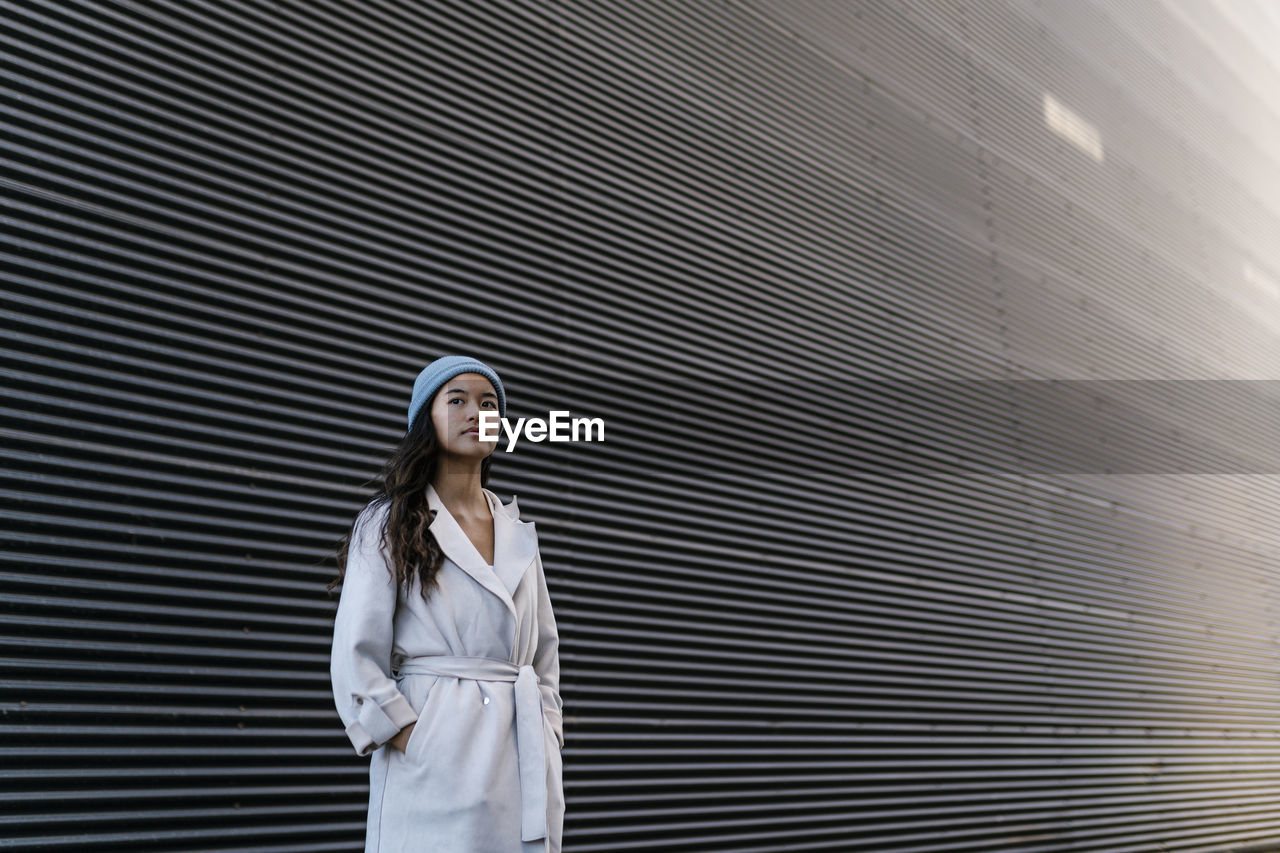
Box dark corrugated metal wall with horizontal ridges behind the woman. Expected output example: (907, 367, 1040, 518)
(0, 0, 1280, 853)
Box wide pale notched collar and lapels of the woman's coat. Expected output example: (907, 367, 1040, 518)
(426, 483, 538, 613)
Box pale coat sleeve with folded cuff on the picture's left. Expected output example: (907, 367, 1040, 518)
(329, 507, 417, 756)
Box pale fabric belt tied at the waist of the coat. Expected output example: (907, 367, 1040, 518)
(397, 654, 547, 841)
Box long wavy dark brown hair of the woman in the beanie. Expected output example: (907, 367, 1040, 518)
(328, 401, 493, 598)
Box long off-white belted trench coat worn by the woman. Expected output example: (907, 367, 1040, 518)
(330, 485, 564, 853)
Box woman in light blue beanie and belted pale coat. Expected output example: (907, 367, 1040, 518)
(330, 356, 564, 853)
